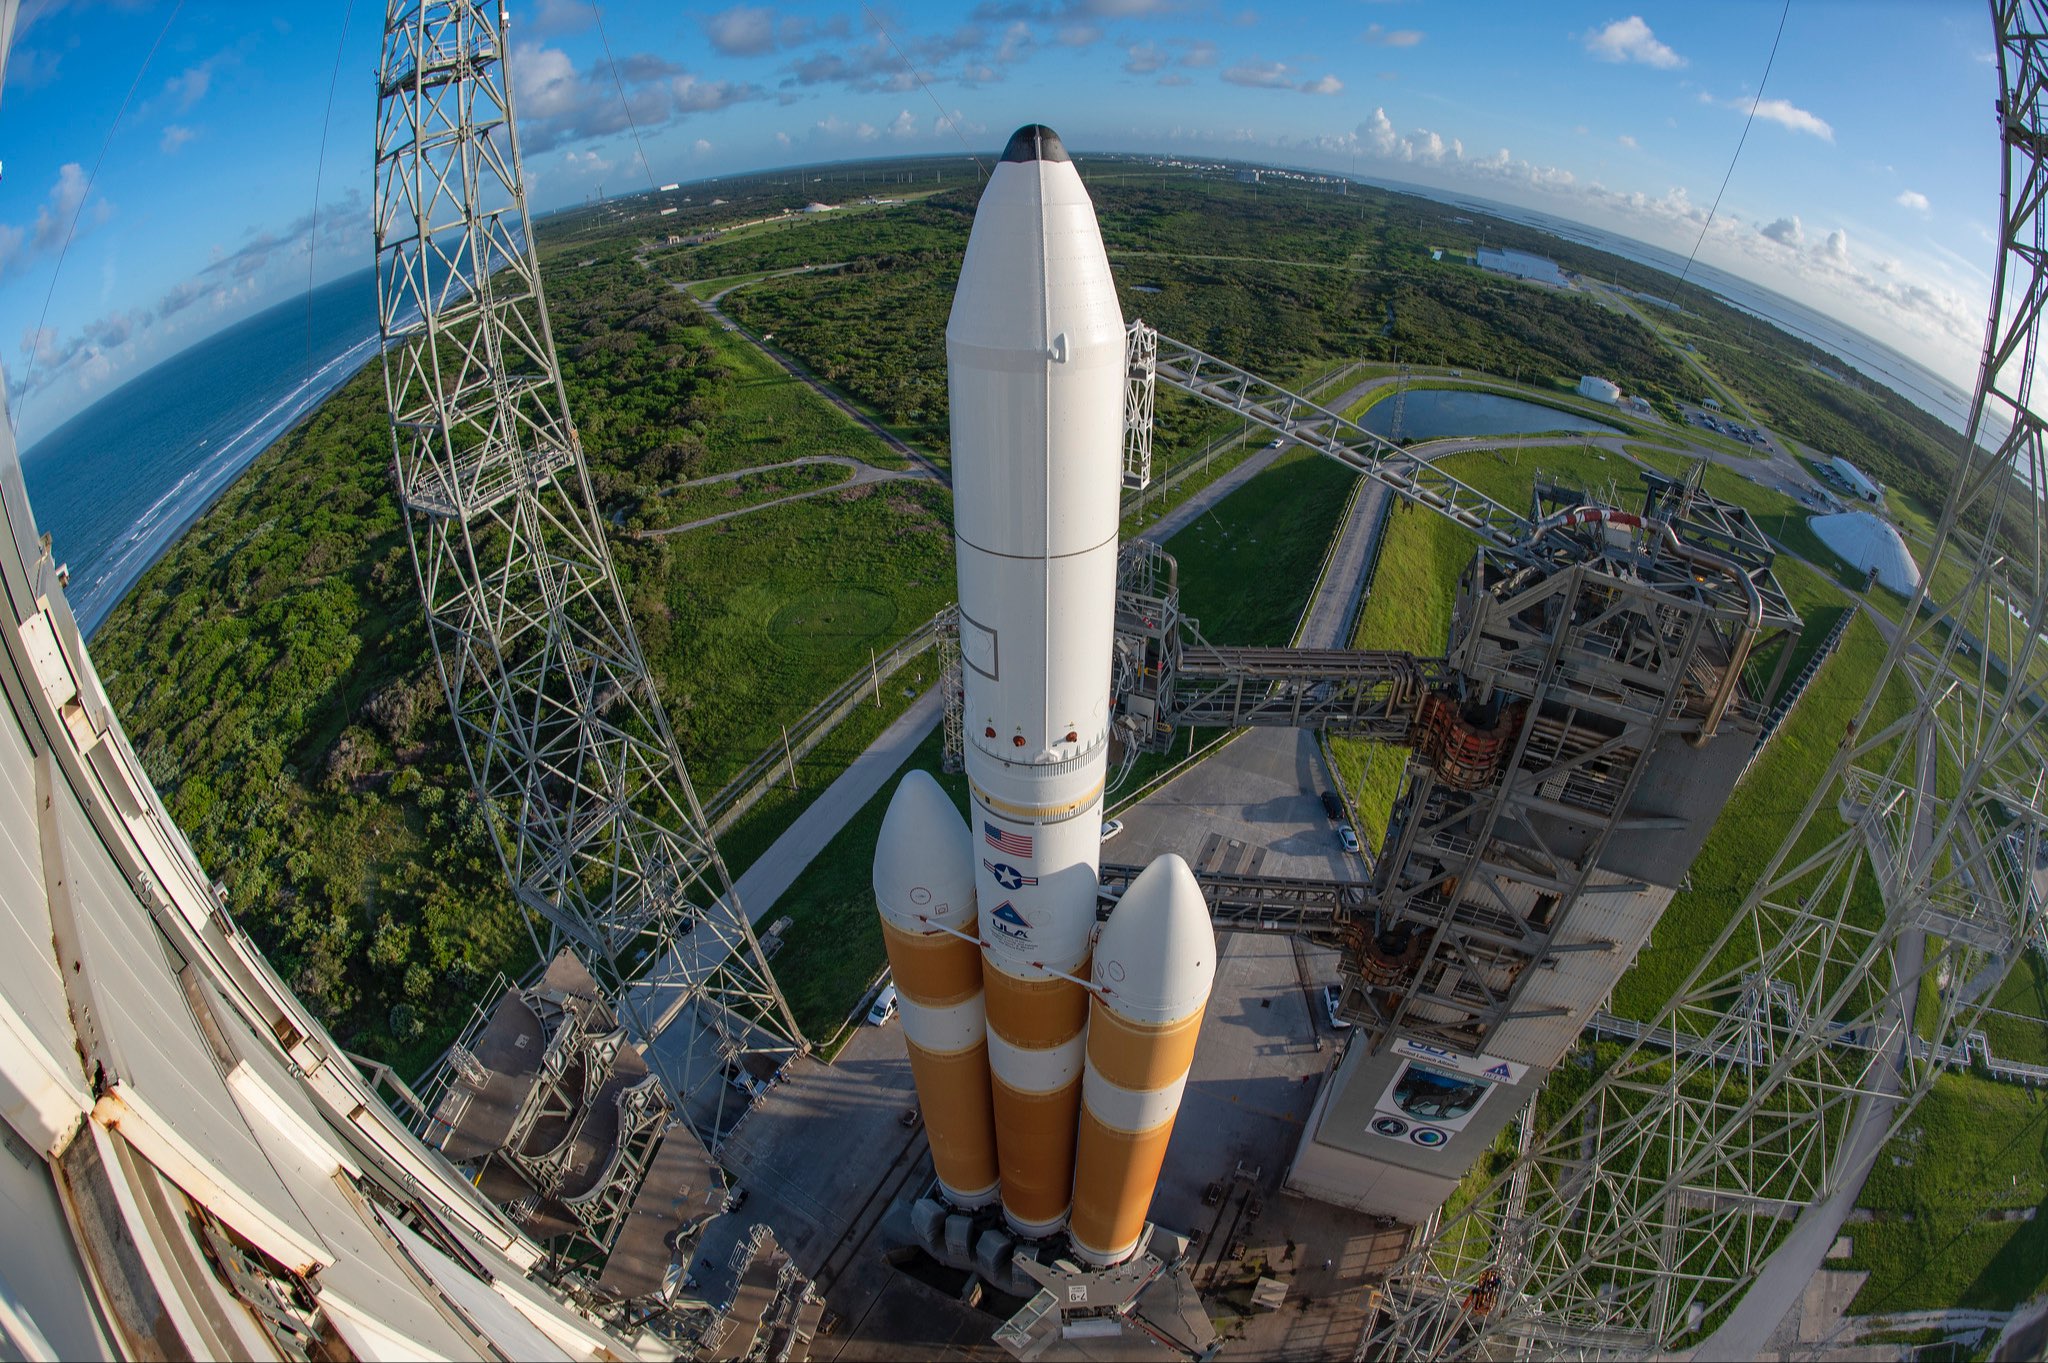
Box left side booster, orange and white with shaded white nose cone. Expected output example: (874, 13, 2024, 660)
(874, 772, 997, 1210)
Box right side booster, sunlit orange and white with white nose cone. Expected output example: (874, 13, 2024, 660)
(1067, 853, 1217, 1265)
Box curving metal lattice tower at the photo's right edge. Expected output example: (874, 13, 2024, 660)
(1362, 0, 2048, 1357)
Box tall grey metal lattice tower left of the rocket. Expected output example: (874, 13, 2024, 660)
(375, 0, 803, 1128)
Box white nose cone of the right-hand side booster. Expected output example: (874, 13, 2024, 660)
(1096, 851, 1217, 1021)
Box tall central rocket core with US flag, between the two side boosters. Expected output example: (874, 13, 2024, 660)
(946, 125, 1124, 1236)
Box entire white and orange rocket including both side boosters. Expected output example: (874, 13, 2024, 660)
(874, 125, 1214, 1263)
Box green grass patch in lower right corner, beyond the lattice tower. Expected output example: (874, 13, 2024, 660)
(1843, 1074, 2048, 1314)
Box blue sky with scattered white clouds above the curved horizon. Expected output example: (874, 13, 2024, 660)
(0, 0, 1999, 442)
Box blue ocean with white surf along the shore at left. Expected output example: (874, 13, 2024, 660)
(20, 270, 377, 636)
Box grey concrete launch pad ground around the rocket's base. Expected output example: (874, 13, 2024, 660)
(707, 863, 1407, 1361)
